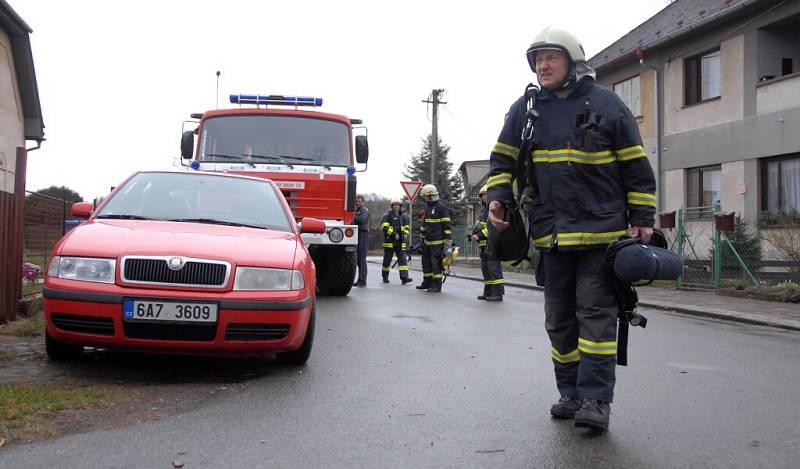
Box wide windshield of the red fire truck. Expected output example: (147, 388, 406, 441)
(200, 115, 350, 166)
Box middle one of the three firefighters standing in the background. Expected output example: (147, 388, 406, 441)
(416, 184, 453, 293)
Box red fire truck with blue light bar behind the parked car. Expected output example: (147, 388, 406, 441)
(181, 95, 369, 296)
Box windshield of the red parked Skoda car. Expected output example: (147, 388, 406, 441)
(96, 172, 292, 231)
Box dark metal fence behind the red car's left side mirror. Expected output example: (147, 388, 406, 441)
(22, 192, 80, 294)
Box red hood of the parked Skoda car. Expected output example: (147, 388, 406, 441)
(56, 220, 298, 269)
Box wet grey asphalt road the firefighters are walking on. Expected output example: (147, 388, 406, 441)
(0, 265, 800, 469)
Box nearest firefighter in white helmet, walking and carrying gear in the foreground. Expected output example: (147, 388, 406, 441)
(488, 24, 656, 430)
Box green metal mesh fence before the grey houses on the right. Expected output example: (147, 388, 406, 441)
(662, 204, 800, 290)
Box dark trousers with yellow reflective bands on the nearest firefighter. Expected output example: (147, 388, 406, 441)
(542, 249, 618, 402)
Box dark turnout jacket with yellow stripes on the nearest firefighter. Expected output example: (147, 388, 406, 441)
(487, 77, 656, 250)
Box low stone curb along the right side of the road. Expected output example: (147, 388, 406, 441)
(368, 261, 800, 332)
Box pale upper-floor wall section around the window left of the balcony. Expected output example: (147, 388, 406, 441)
(664, 35, 744, 135)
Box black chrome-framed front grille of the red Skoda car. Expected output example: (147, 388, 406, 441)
(123, 258, 228, 288)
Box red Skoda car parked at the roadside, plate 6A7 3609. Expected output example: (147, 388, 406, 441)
(43, 171, 326, 365)
